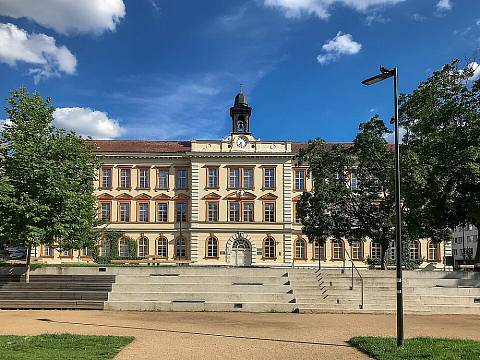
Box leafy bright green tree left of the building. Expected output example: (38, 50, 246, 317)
(0, 88, 99, 281)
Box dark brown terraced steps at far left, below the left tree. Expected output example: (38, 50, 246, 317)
(0, 275, 115, 310)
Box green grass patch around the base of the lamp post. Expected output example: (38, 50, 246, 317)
(349, 336, 480, 360)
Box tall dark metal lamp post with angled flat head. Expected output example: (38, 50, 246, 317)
(362, 66, 404, 347)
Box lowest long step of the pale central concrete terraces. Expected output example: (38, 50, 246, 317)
(105, 301, 297, 312)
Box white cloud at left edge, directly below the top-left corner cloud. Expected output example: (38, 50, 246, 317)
(0, 23, 77, 83)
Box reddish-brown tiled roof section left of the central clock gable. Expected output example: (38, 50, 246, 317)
(87, 140, 192, 153)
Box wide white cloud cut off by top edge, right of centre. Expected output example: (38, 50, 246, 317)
(264, 0, 405, 19)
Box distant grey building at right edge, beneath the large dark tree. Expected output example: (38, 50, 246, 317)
(452, 224, 478, 268)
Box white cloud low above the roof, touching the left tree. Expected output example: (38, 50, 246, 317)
(53, 107, 125, 139)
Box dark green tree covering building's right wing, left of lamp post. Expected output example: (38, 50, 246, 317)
(298, 116, 406, 269)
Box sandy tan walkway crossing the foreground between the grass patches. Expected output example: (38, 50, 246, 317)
(0, 311, 480, 360)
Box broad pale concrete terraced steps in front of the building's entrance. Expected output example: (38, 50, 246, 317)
(105, 267, 296, 312)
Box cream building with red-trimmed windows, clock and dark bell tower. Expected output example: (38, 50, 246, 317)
(32, 92, 443, 267)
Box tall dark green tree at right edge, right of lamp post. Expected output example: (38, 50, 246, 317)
(400, 60, 480, 269)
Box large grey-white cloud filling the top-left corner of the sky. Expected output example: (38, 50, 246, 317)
(0, 0, 125, 34)
